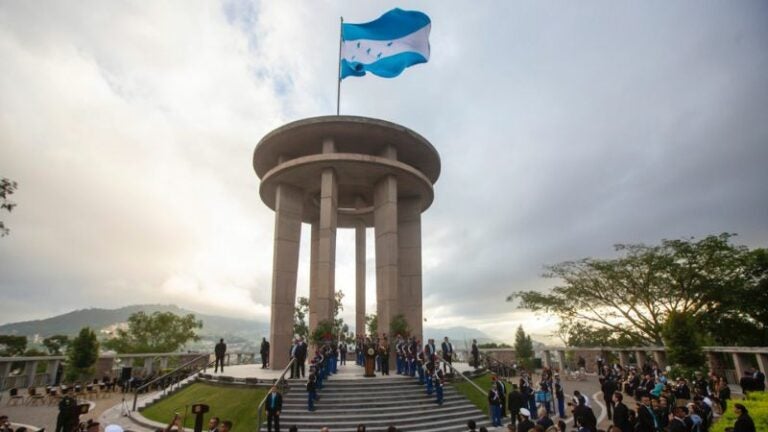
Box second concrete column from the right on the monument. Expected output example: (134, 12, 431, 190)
(373, 176, 399, 346)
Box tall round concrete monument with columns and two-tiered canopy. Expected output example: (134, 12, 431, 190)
(253, 116, 440, 368)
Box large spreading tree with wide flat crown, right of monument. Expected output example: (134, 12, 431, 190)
(507, 233, 768, 345)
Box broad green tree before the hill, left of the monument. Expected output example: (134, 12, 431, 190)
(104, 312, 203, 353)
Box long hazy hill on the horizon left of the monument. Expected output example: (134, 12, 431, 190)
(0, 304, 269, 344)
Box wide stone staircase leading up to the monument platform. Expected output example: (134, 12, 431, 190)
(276, 364, 490, 432)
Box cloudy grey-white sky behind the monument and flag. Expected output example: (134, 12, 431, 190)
(0, 0, 768, 339)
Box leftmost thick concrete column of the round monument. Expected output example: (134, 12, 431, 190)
(269, 184, 304, 369)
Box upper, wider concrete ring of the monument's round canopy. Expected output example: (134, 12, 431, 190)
(253, 116, 440, 184)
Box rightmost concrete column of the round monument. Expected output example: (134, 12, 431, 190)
(397, 198, 424, 343)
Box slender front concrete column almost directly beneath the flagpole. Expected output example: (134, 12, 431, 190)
(309, 166, 338, 334)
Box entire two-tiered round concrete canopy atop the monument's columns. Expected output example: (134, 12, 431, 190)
(253, 116, 440, 228)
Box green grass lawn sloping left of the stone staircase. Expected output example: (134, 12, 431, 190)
(141, 383, 268, 431)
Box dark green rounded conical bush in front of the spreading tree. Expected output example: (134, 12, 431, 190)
(662, 311, 706, 368)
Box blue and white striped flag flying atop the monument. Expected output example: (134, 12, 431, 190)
(339, 9, 432, 79)
